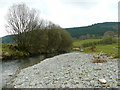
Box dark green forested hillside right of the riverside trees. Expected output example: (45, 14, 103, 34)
(66, 22, 120, 39)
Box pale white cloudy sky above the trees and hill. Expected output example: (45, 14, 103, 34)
(0, 0, 120, 37)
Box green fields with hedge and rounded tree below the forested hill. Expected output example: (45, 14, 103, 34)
(73, 31, 120, 58)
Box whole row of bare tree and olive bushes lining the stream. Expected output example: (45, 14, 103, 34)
(6, 3, 73, 54)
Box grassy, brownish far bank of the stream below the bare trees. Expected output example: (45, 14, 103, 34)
(0, 44, 67, 61)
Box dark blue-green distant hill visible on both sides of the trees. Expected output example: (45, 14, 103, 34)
(2, 22, 120, 43)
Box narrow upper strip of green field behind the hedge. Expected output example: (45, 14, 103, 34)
(73, 39, 102, 47)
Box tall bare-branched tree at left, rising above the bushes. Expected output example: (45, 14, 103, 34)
(7, 4, 42, 50)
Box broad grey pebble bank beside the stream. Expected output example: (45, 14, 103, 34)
(13, 52, 118, 88)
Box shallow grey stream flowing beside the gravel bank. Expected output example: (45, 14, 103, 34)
(0, 54, 55, 88)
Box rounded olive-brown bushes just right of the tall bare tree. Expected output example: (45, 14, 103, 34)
(27, 24, 72, 54)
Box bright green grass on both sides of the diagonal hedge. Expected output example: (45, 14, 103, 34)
(73, 39, 120, 58)
